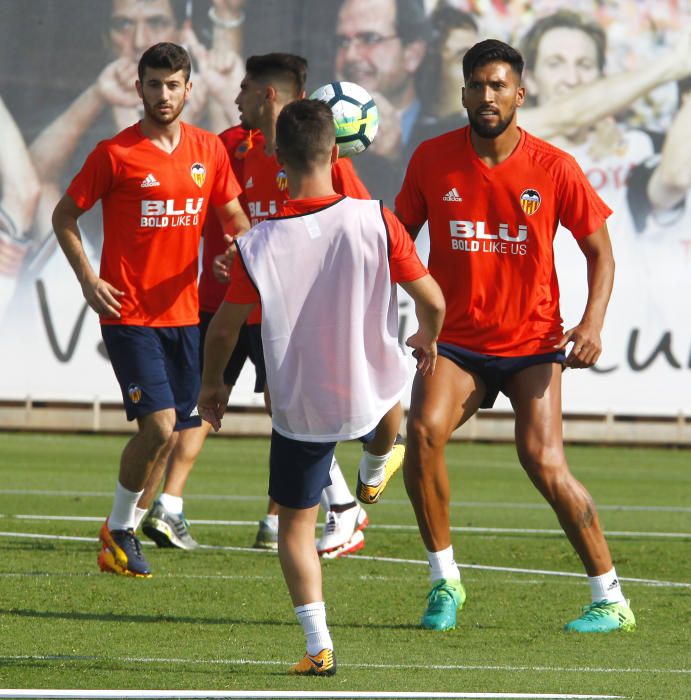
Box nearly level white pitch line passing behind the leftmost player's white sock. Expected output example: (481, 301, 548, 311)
(6, 513, 691, 539)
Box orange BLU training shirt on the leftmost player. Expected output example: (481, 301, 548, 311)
(67, 123, 240, 327)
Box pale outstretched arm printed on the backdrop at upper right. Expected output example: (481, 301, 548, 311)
(520, 30, 691, 139)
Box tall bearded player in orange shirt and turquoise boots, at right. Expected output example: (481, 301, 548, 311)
(396, 39, 635, 632)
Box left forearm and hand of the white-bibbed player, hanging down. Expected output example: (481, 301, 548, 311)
(197, 301, 255, 432)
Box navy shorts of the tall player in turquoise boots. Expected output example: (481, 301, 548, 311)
(437, 343, 566, 408)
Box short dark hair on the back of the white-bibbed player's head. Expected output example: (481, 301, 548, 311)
(276, 100, 336, 172)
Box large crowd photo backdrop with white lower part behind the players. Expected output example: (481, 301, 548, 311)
(0, 0, 691, 416)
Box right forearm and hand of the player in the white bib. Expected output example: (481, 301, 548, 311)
(400, 274, 446, 375)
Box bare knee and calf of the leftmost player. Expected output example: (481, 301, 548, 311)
(120, 408, 175, 491)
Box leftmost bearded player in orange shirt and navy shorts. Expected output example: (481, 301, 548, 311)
(53, 42, 249, 578)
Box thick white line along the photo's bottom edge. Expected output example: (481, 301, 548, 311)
(0, 690, 624, 700)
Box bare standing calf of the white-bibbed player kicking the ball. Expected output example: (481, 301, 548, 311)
(278, 504, 324, 607)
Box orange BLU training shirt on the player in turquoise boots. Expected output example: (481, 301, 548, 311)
(396, 127, 612, 357)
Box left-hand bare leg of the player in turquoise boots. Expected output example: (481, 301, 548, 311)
(403, 357, 485, 552)
